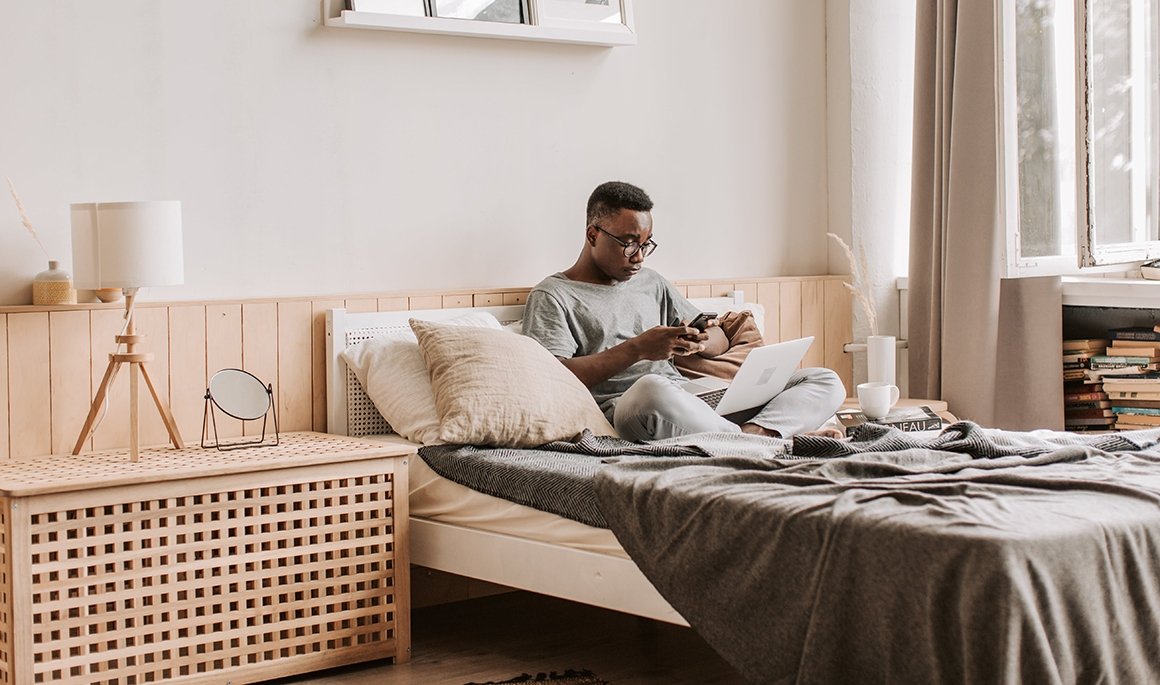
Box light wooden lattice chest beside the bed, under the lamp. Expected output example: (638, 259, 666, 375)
(0, 433, 413, 685)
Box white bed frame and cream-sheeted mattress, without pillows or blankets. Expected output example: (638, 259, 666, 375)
(326, 297, 763, 625)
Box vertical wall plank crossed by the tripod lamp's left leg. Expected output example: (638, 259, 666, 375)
(89, 309, 129, 450)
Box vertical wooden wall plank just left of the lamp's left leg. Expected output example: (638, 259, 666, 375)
(49, 311, 92, 454)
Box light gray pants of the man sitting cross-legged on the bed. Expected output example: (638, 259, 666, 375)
(612, 369, 846, 442)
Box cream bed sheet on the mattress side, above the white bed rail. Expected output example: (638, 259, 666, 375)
(367, 435, 629, 559)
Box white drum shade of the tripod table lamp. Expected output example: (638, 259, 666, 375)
(72, 201, 186, 290)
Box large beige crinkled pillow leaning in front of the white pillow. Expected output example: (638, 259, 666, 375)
(411, 319, 616, 447)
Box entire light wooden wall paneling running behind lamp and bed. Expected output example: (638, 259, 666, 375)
(0, 276, 853, 458)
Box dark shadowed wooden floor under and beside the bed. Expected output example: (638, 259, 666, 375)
(273, 592, 745, 685)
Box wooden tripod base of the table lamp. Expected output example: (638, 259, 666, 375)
(73, 287, 186, 461)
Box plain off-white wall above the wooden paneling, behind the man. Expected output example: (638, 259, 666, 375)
(0, 0, 827, 305)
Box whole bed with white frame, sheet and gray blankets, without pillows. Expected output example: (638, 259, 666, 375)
(327, 309, 1160, 683)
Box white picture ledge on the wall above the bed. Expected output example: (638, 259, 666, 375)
(322, 0, 637, 48)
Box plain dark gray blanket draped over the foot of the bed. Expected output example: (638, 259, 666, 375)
(595, 424, 1160, 684)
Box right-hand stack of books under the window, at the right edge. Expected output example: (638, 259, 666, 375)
(1103, 327, 1160, 430)
